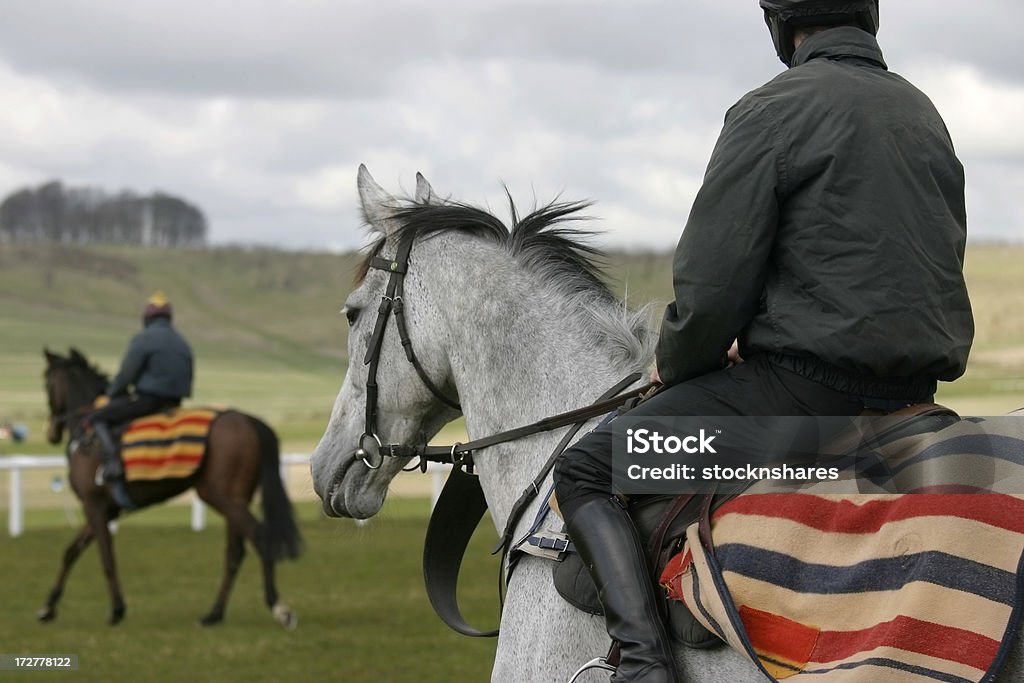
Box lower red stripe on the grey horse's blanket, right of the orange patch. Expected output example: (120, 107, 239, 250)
(806, 616, 999, 671)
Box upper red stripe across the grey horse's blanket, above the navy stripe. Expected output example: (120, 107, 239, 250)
(713, 494, 1024, 533)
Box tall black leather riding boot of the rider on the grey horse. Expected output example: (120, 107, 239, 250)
(566, 498, 680, 683)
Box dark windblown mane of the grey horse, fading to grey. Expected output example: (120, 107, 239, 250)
(356, 190, 655, 368)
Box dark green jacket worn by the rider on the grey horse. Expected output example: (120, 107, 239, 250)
(657, 27, 974, 395)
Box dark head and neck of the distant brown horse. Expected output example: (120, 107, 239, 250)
(43, 348, 108, 443)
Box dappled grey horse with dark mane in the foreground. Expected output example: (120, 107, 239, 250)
(311, 166, 1024, 683)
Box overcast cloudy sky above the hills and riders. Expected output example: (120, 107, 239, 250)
(0, 0, 1024, 249)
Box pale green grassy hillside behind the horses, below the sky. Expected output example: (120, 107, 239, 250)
(0, 240, 1024, 453)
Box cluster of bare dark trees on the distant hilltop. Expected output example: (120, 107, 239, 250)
(0, 180, 207, 247)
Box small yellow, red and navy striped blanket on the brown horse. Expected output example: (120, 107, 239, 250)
(121, 409, 220, 481)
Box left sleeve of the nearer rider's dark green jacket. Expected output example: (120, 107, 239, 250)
(656, 97, 785, 385)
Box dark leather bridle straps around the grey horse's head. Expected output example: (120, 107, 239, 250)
(355, 230, 462, 470)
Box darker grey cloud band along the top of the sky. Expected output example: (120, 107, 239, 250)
(0, 0, 1024, 98)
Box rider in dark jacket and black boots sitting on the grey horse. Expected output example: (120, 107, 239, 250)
(555, 0, 974, 683)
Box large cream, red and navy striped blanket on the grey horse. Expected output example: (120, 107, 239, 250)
(660, 418, 1024, 683)
